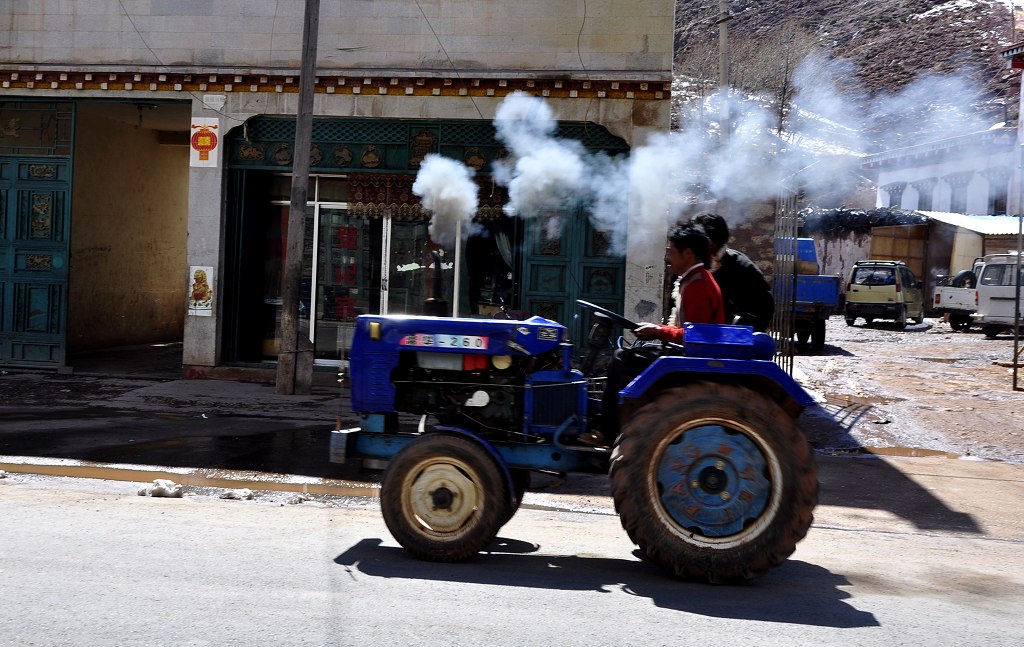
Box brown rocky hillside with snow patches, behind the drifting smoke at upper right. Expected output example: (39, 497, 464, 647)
(676, 0, 1020, 153)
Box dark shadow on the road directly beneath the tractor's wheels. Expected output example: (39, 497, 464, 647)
(334, 537, 880, 629)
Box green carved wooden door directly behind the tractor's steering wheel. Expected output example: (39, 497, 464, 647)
(521, 208, 626, 360)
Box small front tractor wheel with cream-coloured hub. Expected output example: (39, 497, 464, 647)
(381, 433, 514, 562)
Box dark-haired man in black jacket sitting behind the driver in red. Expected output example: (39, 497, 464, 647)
(693, 213, 775, 333)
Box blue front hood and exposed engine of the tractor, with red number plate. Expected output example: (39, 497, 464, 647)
(349, 314, 586, 437)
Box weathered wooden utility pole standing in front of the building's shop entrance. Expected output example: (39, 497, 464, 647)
(274, 0, 319, 395)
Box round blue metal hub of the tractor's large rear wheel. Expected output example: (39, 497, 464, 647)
(657, 425, 771, 537)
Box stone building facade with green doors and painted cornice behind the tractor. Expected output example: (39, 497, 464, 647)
(0, 0, 674, 377)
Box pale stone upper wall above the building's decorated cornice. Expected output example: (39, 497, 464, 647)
(0, 0, 675, 80)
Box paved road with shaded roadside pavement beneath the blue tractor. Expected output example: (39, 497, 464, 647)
(0, 366, 1024, 646)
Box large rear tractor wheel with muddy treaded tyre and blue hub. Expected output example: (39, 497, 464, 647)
(610, 383, 818, 583)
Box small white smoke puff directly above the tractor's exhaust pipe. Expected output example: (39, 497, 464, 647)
(413, 154, 479, 248)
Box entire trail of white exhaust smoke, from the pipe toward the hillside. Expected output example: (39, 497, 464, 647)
(414, 63, 986, 255)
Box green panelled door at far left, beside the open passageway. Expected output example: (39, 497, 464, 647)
(0, 157, 71, 368)
